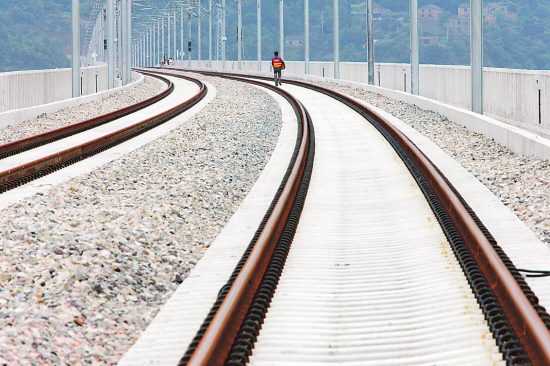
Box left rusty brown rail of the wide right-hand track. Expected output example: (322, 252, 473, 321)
(170, 72, 311, 366)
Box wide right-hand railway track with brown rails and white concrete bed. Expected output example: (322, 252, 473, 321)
(120, 72, 550, 365)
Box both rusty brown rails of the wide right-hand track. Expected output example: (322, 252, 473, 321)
(119, 70, 550, 366)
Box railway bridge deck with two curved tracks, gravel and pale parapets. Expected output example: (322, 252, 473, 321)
(0, 66, 550, 366)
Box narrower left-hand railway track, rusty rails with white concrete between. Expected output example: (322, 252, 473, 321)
(0, 73, 207, 193)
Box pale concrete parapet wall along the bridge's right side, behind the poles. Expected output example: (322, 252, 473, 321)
(195, 61, 550, 137)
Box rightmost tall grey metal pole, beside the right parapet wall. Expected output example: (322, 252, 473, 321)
(470, 0, 483, 114)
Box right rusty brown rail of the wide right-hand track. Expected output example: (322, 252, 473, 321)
(181, 70, 550, 366)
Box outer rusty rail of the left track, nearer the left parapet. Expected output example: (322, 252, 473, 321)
(0, 73, 174, 159)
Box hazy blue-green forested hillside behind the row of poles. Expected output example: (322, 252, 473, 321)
(0, 0, 550, 71)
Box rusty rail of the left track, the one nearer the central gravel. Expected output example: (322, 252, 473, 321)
(0, 73, 207, 193)
